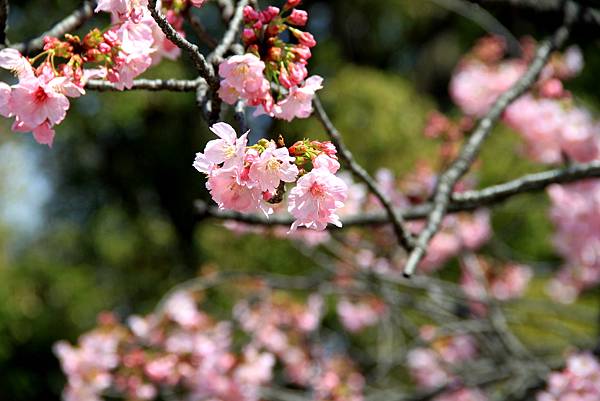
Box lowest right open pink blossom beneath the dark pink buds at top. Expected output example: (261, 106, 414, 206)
(274, 75, 323, 121)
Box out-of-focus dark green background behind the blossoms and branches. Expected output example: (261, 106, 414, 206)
(0, 0, 600, 401)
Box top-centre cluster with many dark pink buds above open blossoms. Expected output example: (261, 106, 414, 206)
(219, 0, 323, 121)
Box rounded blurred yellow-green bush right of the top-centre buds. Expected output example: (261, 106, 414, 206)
(278, 66, 436, 175)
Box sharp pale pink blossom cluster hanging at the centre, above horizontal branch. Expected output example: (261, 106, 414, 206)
(193, 122, 348, 231)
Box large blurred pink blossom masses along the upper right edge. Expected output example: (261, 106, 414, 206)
(450, 38, 600, 302)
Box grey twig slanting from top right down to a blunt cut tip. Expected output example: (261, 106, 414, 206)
(404, 6, 576, 277)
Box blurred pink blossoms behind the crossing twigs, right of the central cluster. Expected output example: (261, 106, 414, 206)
(218, 163, 492, 270)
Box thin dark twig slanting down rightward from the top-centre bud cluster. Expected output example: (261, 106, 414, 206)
(313, 96, 414, 250)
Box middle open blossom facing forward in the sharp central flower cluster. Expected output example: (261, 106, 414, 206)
(250, 143, 298, 193)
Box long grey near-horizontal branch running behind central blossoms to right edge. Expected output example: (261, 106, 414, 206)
(198, 161, 600, 227)
